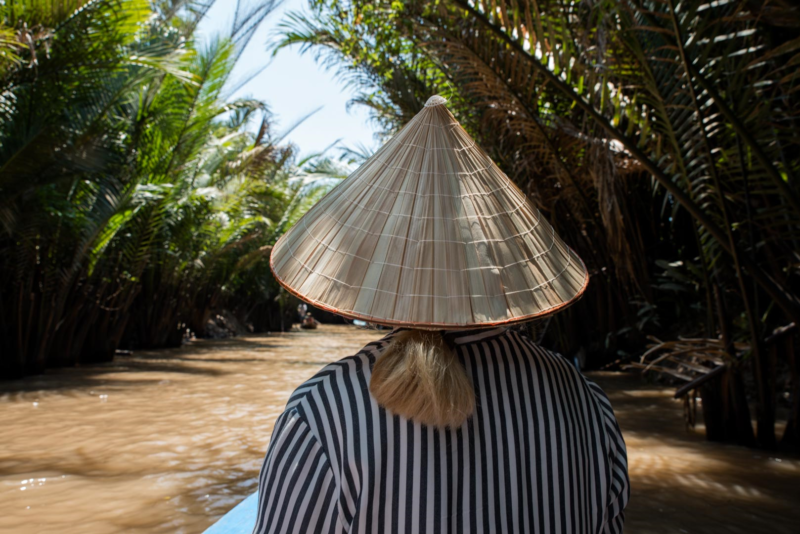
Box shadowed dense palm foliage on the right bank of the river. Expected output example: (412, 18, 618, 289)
(282, 0, 800, 447)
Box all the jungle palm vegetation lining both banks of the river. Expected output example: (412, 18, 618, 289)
(0, 0, 800, 449)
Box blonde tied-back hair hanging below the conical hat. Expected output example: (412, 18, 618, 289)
(369, 330, 475, 427)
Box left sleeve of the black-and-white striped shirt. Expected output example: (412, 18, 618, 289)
(253, 409, 339, 534)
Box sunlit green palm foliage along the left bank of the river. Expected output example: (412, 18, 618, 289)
(0, 0, 335, 378)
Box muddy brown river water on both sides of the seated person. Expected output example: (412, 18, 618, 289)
(0, 326, 800, 534)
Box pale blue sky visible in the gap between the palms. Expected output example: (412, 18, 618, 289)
(199, 0, 376, 157)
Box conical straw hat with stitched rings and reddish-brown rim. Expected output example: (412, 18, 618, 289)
(270, 96, 589, 329)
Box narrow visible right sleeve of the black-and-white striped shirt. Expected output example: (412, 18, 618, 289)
(587, 381, 631, 534)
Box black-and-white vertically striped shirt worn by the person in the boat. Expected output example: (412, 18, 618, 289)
(254, 328, 630, 534)
